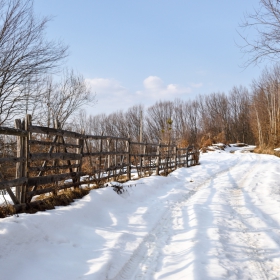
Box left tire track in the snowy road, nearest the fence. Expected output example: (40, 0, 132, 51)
(107, 161, 240, 280)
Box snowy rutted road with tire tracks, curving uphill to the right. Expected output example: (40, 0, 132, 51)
(112, 156, 280, 279)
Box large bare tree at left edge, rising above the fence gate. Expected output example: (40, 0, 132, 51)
(0, 0, 67, 125)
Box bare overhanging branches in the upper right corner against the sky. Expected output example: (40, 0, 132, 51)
(239, 0, 280, 67)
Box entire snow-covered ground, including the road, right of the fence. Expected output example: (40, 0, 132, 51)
(0, 148, 280, 280)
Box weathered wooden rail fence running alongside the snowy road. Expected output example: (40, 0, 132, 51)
(0, 115, 199, 211)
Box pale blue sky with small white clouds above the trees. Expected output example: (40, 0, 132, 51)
(34, 0, 262, 115)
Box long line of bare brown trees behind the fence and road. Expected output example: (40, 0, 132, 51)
(72, 64, 280, 151)
